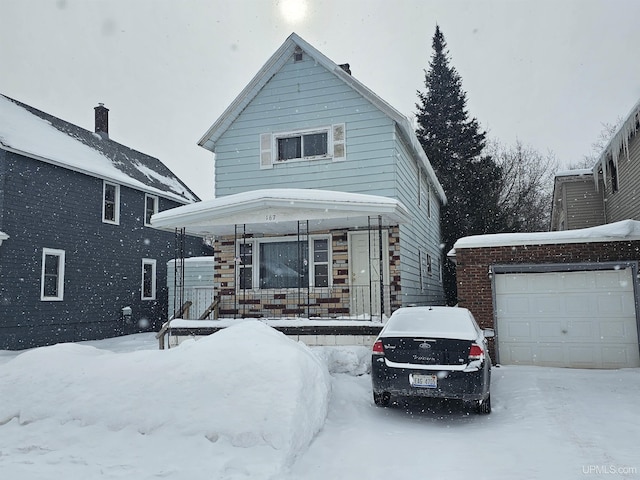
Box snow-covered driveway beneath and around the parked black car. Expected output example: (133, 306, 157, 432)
(286, 366, 640, 479)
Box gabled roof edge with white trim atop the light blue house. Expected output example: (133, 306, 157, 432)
(198, 33, 447, 203)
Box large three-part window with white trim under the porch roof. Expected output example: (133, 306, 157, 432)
(236, 235, 331, 290)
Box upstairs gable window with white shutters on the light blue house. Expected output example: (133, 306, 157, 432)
(260, 123, 345, 168)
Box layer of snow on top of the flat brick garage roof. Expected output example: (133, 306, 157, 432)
(447, 220, 640, 253)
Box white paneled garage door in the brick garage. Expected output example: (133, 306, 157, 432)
(495, 268, 640, 368)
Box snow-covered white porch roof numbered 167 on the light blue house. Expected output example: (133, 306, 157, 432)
(151, 188, 411, 236)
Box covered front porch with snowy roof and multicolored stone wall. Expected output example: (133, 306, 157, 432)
(151, 189, 410, 320)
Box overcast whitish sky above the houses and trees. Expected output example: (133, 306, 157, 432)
(0, 0, 640, 199)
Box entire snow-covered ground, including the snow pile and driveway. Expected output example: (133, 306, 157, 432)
(0, 321, 640, 480)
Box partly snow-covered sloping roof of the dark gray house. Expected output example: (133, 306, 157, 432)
(0, 95, 199, 203)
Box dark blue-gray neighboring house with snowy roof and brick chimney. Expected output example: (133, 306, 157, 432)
(0, 95, 206, 349)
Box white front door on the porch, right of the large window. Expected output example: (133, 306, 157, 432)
(349, 230, 389, 317)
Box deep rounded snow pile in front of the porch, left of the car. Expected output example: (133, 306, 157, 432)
(0, 321, 330, 478)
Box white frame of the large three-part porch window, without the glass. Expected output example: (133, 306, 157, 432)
(235, 234, 333, 290)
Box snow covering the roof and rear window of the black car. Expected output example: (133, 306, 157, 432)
(380, 307, 478, 340)
